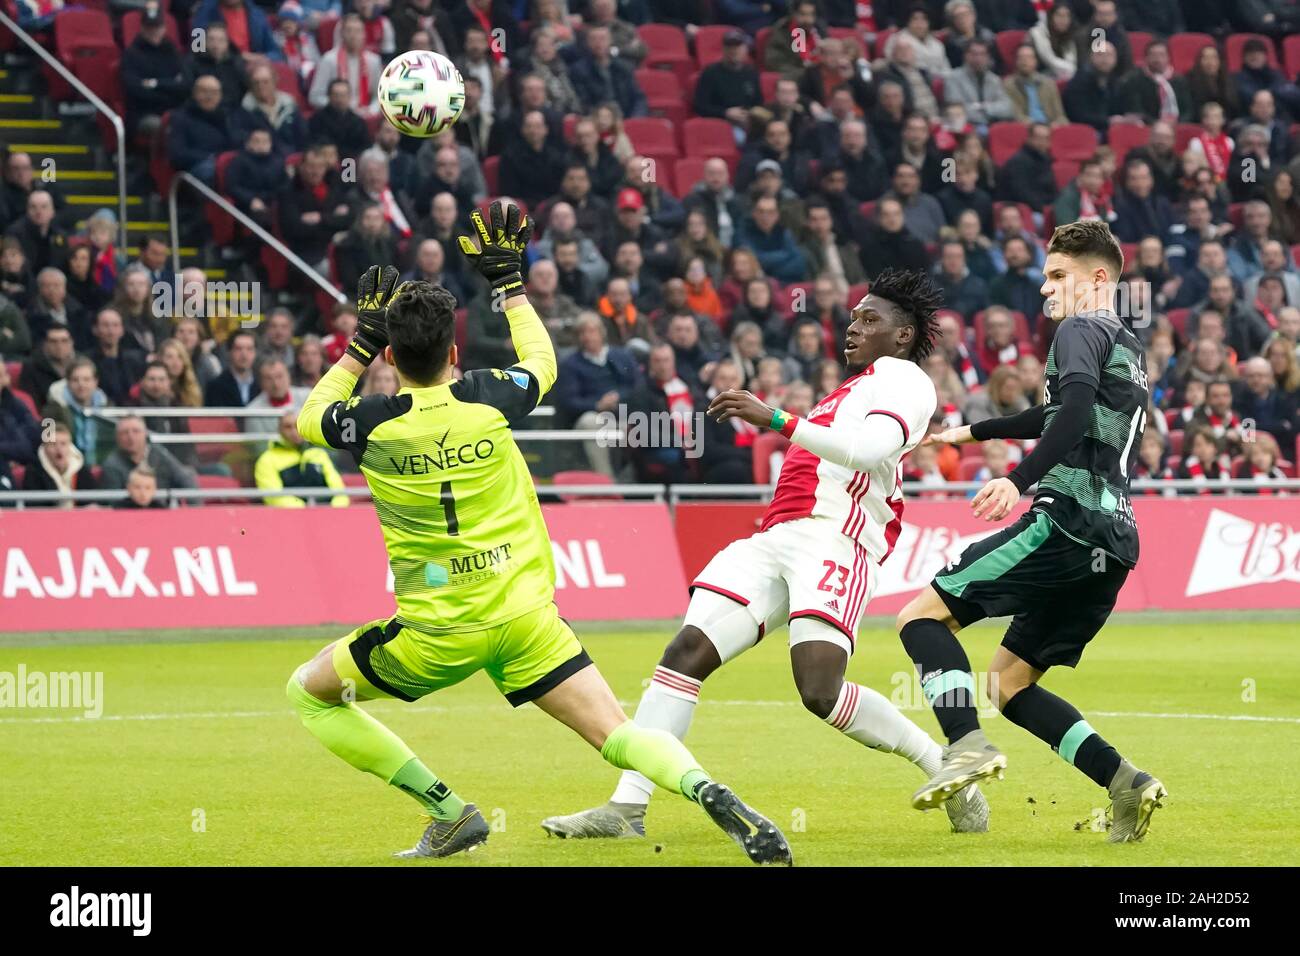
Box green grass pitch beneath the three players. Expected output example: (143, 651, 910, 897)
(0, 615, 1300, 866)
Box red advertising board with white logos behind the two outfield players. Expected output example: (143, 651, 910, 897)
(676, 497, 1300, 614)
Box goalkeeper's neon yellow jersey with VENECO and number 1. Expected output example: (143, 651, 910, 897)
(298, 306, 556, 632)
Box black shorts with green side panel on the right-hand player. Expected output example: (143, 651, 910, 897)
(933, 509, 1130, 671)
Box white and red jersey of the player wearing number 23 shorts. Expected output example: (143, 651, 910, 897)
(762, 358, 937, 563)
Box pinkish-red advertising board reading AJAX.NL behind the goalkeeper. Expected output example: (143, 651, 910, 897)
(0, 502, 686, 632)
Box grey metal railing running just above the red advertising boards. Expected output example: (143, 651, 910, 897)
(0, 479, 1300, 509)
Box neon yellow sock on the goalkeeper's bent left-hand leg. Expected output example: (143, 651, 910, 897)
(285, 674, 465, 819)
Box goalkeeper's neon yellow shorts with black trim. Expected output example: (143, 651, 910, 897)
(333, 604, 592, 708)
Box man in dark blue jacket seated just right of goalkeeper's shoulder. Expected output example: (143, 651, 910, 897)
(555, 313, 641, 477)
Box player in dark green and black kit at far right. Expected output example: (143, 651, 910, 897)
(898, 221, 1166, 843)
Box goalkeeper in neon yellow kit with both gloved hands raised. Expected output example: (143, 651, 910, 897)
(286, 202, 790, 864)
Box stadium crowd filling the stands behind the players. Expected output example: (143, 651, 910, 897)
(0, 0, 1300, 506)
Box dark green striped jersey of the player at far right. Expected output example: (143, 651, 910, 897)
(1034, 312, 1149, 566)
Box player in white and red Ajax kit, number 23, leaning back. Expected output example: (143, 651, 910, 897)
(542, 271, 988, 838)
